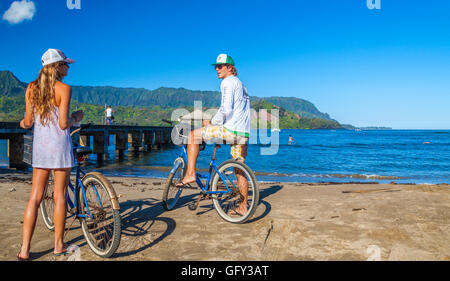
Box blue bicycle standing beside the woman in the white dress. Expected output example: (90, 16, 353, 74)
(40, 124, 121, 257)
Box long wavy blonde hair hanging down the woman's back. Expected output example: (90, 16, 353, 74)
(28, 61, 65, 126)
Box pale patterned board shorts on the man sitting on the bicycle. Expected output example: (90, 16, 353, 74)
(202, 125, 248, 162)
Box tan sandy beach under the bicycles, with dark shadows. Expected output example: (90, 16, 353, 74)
(0, 173, 450, 261)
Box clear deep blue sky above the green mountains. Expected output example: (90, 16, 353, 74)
(0, 0, 450, 129)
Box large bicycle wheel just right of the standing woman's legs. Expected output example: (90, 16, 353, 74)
(78, 172, 121, 258)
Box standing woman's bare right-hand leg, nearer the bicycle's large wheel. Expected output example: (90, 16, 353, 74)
(53, 168, 71, 254)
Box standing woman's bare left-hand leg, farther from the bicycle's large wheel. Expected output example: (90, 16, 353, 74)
(19, 168, 50, 258)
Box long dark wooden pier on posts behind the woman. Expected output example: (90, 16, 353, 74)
(0, 122, 172, 169)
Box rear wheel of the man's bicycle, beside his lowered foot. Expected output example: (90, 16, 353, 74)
(211, 160, 259, 223)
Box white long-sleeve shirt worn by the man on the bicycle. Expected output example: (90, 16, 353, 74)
(211, 75, 250, 137)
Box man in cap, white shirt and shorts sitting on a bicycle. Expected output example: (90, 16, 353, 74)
(177, 54, 250, 216)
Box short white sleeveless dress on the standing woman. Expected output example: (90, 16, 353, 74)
(32, 106, 75, 169)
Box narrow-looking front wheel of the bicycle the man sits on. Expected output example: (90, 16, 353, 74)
(162, 157, 186, 211)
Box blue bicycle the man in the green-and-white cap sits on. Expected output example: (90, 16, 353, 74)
(162, 122, 259, 223)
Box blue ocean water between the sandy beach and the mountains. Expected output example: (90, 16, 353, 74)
(0, 130, 450, 184)
